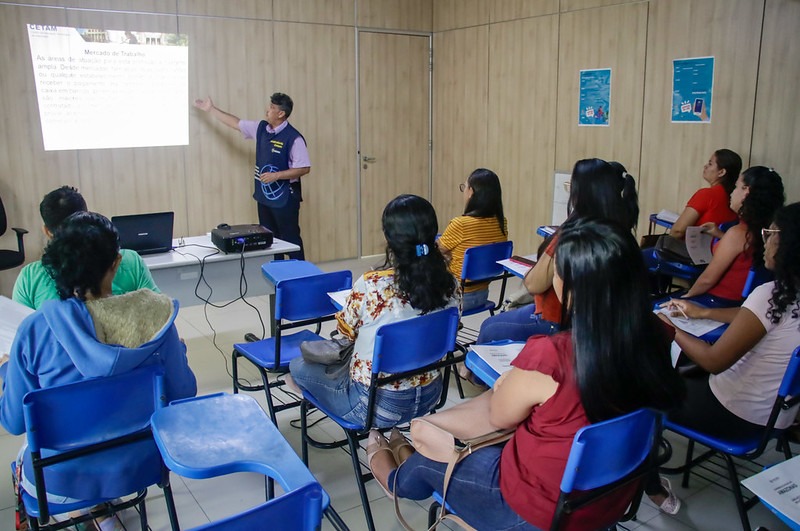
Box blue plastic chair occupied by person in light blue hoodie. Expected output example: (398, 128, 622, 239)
(22, 365, 177, 530)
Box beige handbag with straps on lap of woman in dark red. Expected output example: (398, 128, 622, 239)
(392, 414, 516, 531)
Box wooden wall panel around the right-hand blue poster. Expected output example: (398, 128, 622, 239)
(639, 0, 763, 232)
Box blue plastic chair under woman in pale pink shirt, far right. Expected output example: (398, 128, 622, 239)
(661, 347, 800, 531)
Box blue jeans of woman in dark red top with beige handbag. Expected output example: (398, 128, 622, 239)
(389, 445, 537, 531)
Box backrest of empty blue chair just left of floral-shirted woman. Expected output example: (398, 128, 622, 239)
(275, 271, 353, 321)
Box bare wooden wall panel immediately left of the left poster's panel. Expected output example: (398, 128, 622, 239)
(488, 15, 558, 254)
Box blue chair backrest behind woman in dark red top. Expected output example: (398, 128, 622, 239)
(561, 409, 657, 493)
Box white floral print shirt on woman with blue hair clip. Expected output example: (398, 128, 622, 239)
(336, 270, 459, 391)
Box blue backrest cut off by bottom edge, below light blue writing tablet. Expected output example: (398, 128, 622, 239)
(192, 483, 322, 531)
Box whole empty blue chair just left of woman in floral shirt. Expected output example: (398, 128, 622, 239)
(231, 270, 353, 425)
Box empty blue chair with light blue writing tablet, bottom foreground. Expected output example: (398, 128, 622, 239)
(152, 393, 346, 530)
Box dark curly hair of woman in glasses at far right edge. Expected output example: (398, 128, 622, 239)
(767, 203, 800, 324)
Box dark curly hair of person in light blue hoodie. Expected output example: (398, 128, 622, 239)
(42, 212, 119, 301)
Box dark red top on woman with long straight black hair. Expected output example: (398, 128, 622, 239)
(500, 331, 630, 530)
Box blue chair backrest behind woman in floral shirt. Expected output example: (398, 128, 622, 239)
(372, 308, 458, 374)
